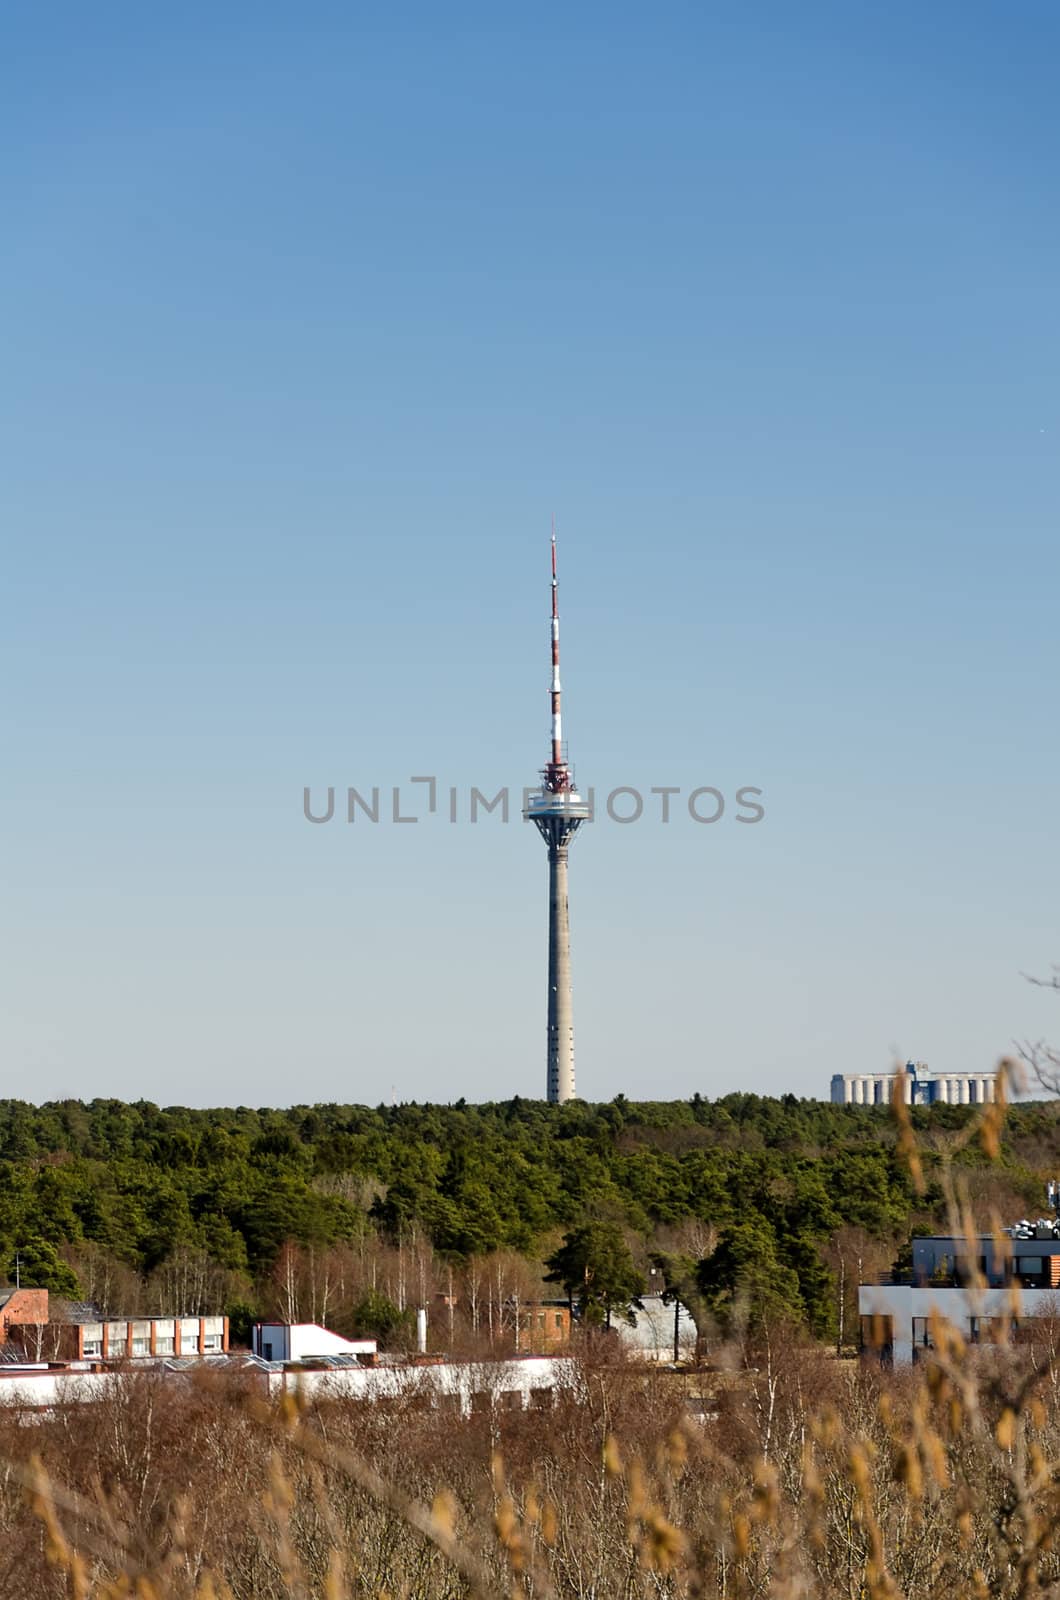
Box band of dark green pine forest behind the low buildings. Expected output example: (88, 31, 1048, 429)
(0, 1094, 1057, 1344)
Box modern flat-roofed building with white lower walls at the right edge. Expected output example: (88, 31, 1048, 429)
(858, 1219, 1060, 1366)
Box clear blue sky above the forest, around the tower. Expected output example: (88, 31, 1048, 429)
(0, 0, 1060, 1104)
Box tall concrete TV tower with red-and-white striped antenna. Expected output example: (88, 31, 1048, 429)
(524, 522, 591, 1106)
